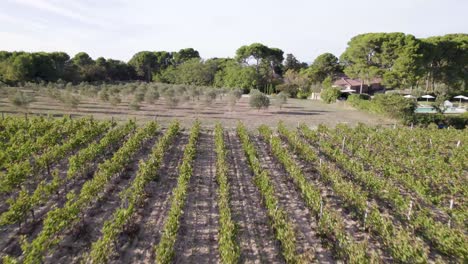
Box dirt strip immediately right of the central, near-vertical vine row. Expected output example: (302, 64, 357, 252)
(225, 132, 284, 263)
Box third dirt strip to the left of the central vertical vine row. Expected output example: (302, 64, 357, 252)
(45, 136, 159, 263)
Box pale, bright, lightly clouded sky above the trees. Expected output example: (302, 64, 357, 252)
(0, 0, 468, 63)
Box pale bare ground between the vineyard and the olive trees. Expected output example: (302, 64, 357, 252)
(0, 96, 395, 128)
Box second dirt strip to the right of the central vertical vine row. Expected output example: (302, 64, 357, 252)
(251, 136, 336, 263)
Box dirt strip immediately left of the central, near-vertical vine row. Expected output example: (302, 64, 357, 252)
(174, 131, 220, 263)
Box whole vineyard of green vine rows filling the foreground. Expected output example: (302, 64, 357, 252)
(0, 116, 468, 263)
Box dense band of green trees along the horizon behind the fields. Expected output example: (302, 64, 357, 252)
(0, 33, 468, 94)
